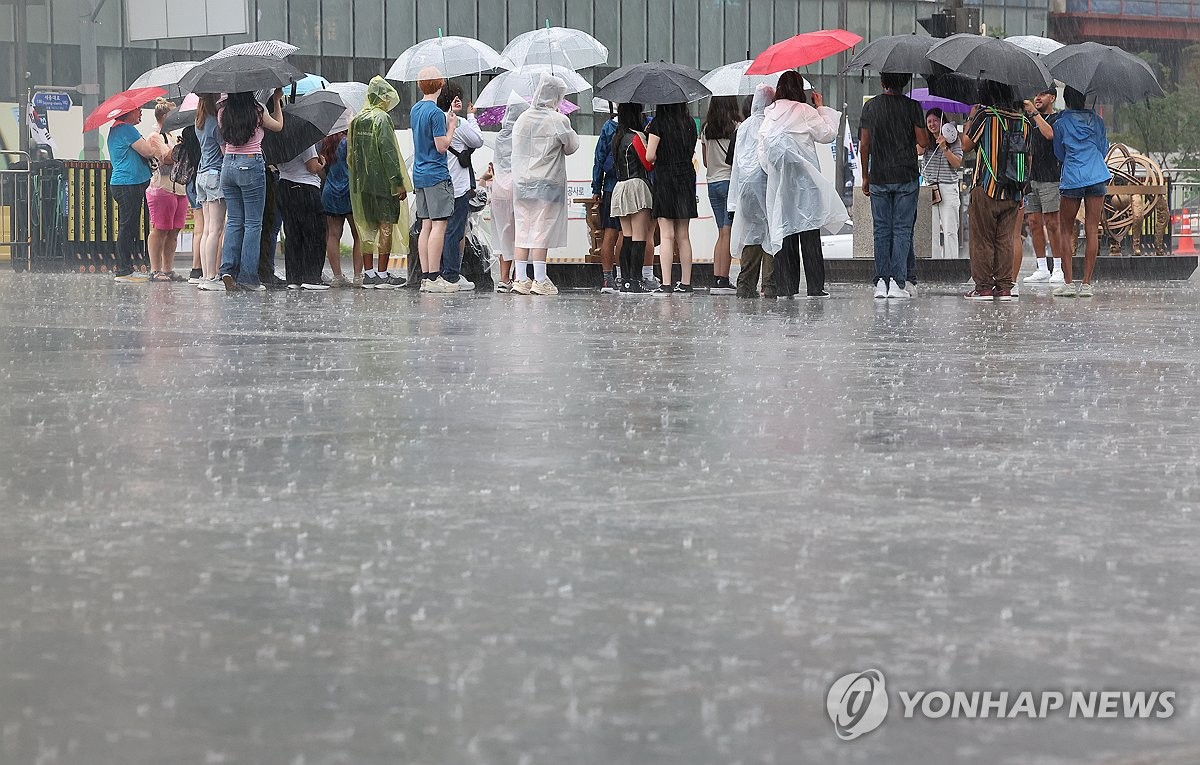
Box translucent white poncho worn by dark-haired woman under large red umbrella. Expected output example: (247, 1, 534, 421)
(758, 95, 850, 254)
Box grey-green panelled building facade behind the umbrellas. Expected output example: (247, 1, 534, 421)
(0, 0, 1048, 129)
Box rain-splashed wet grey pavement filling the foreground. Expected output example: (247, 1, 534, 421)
(0, 272, 1200, 765)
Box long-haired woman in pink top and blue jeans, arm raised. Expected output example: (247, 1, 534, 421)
(217, 88, 283, 291)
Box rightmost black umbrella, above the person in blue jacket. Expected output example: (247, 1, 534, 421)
(1043, 42, 1164, 103)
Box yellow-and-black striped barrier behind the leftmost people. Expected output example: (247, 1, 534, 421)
(62, 161, 150, 273)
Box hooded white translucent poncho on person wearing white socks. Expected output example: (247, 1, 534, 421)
(512, 74, 580, 249)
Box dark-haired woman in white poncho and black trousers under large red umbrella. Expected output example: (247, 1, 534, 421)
(758, 72, 850, 297)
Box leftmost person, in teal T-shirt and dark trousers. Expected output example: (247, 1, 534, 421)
(108, 102, 169, 283)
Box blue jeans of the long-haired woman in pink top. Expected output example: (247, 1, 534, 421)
(221, 153, 266, 287)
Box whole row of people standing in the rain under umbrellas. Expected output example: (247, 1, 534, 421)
(108, 67, 1110, 301)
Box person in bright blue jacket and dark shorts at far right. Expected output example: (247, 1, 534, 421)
(1054, 86, 1112, 297)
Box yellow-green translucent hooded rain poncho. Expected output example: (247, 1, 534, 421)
(346, 77, 413, 254)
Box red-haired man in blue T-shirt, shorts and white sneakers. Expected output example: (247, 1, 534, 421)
(409, 67, 458, 293)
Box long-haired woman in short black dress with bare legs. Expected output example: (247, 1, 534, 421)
(646, 103, 700, 297)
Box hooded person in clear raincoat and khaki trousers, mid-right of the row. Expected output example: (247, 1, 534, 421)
(728, 85, 775, 297)
